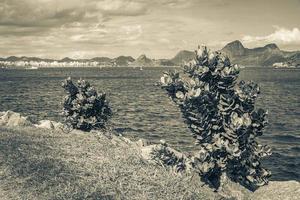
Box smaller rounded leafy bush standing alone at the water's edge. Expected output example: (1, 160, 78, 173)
(62, 77, 112, 131)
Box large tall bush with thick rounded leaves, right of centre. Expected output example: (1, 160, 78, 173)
(161, 47, 271, 190)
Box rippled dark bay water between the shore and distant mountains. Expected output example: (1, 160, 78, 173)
(0, 68, 300, 181)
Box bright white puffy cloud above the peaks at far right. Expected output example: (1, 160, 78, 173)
(242, 26, 300, 44)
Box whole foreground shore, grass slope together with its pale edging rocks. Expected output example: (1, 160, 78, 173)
(0, 111, 300, 200)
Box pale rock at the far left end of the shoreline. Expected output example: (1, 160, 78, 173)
(0, 110, 32, 126)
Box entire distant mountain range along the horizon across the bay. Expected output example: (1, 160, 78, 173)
(0, 40, 300, 67)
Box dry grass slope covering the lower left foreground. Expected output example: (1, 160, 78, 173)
(0, 127, 219, 200)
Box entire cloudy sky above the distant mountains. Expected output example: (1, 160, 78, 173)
(0, 0, 300, 59)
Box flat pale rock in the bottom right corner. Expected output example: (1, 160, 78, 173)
(251, 181, 300, 200)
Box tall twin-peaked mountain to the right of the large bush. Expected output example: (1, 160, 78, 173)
(220, 40, 300, 66)
